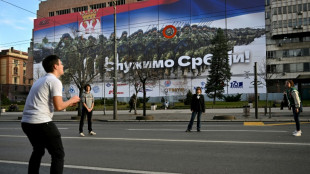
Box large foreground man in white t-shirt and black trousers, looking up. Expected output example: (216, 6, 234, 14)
(21, 55, 80, 174)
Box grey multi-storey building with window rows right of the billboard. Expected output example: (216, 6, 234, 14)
(265, 0, 310, 99)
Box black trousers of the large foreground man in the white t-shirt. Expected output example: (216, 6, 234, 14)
(22, 122, 65, 174)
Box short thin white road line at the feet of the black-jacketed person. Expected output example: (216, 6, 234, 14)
(127, 129, 287, 133)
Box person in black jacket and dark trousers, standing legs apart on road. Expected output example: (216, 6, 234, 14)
(186, 87, 206, 132)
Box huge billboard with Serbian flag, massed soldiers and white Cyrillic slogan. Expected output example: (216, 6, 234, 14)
(34, 0, 266, 97)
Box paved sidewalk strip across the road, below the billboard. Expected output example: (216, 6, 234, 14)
(0, 107, 310, 122)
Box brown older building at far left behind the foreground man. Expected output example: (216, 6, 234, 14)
(0, 47, 33, 102)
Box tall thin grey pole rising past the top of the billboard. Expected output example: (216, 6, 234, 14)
(113, 0, 117, 120)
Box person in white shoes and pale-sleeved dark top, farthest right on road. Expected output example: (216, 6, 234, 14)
(285, 80, 302, 136)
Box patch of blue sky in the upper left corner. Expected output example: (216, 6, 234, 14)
(0, 0, 40, 52)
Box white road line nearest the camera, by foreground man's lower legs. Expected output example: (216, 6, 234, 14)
(0, 160, 180, 174)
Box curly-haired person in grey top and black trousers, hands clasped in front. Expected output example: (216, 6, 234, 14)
(79, 84, 96, 137)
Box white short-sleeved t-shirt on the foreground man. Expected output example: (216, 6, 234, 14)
(21, 73, 62, 124)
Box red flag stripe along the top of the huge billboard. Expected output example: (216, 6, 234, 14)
(34, 0, 179, 31)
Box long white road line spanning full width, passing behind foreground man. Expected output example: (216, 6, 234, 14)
(0, 135, 310, 146)
